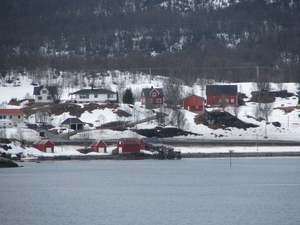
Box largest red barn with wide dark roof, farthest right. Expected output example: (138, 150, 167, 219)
(206, 85, 237, 106)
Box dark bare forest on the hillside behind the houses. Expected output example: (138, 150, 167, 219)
(0, 0, 300, 83)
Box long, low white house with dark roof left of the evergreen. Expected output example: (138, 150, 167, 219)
(71, 88, 118, 103)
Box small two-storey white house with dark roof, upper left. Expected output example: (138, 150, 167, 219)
(33, 86, 58, 103)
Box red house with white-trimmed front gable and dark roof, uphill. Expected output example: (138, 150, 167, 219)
(141, 86, 164, 109)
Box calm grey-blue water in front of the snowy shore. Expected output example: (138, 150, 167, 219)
(0, 158, 300, 225)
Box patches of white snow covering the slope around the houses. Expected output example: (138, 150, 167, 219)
(0, 72, 300, 154)
